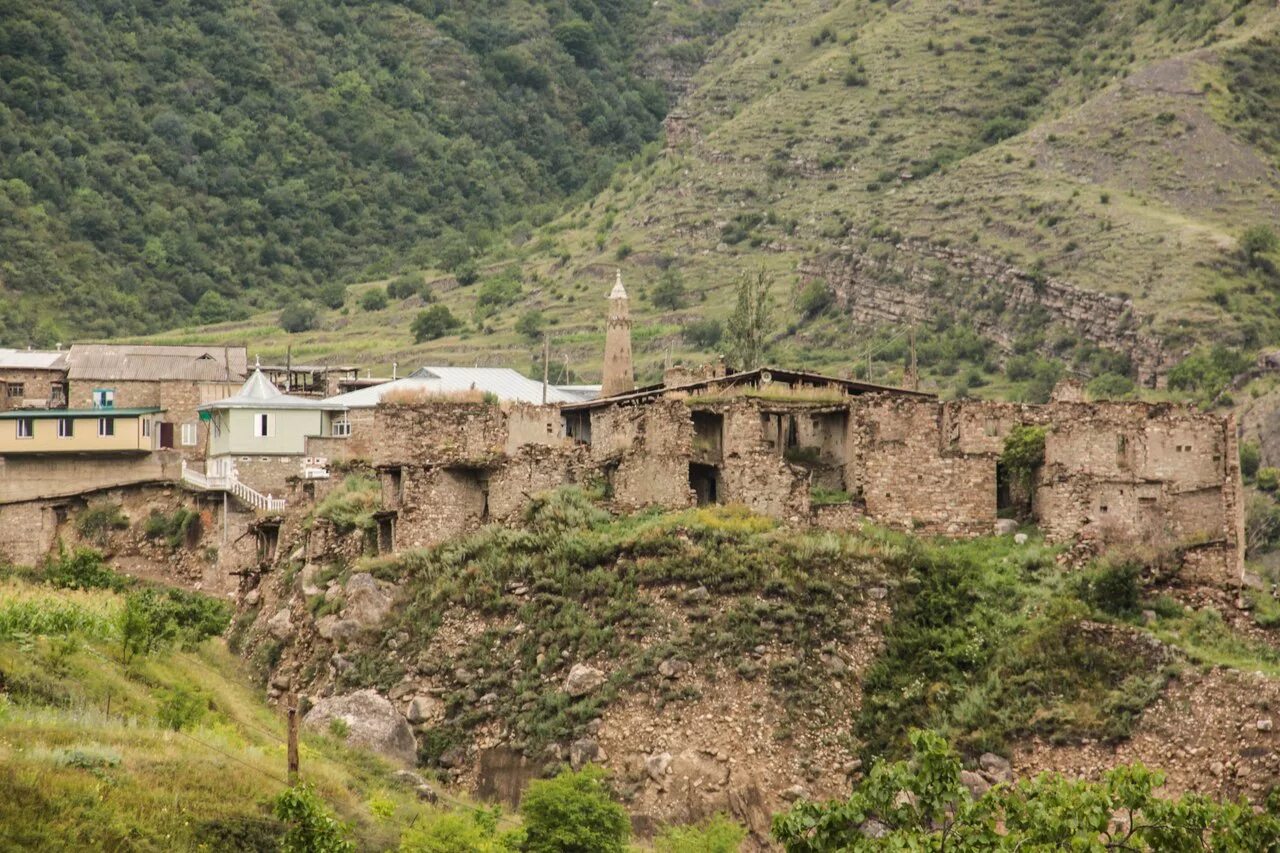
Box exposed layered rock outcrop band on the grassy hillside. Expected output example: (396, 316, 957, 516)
(799, 240, 1175, 387)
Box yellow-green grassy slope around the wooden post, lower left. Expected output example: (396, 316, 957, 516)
(0, 560, 499, 850)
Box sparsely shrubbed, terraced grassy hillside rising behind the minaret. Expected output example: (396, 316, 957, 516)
(129, 0, 1280, 398)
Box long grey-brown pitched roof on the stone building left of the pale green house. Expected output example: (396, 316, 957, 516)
(67, 343, 248, 382)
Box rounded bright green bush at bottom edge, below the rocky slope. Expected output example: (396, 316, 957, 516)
(520, 767, 631, 853)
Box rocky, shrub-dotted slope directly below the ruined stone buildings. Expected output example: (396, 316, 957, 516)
(215, 492, 1280, 841)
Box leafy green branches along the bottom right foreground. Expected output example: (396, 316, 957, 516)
(773, 730, 1280, 853)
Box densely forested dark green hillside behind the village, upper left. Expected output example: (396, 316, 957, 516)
(0, 0, 739, 345)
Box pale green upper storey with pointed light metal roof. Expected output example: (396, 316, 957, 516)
(198, 369, 347, 457)
